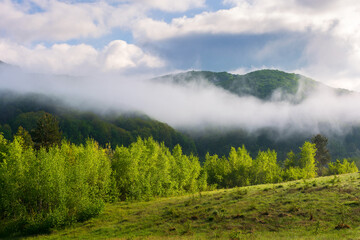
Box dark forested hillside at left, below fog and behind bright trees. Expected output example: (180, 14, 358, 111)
(0, 91, 196, 153)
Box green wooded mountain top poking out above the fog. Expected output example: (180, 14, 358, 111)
(155, 69, 349, 102)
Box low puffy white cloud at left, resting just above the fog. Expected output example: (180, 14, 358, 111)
(0, 40, 165, 75)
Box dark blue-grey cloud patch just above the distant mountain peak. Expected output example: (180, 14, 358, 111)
(142, 33, 308, 71)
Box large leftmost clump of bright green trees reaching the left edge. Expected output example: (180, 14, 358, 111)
(0, 135, 111, 233)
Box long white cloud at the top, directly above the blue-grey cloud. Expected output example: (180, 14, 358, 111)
(135, 0, 337, 40)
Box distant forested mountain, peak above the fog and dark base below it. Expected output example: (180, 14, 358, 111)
(154, 69, 360, 163)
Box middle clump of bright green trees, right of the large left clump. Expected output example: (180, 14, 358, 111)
(112, 138, 206, 200)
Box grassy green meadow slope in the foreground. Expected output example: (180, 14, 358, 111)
(21, 173, 360, 239)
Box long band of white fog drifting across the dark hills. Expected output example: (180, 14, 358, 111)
(0, 67, 360, 135)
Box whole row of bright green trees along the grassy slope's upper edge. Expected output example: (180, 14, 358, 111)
(0, 114, 358, 236)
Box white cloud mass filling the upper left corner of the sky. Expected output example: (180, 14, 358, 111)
(0, 0, 205, 43)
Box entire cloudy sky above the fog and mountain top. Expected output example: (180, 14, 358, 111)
(0, 0, 360, 91)
